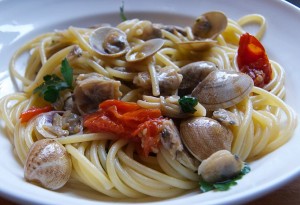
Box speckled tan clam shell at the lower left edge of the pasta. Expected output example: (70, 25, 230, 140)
(24, 139, 72, 190)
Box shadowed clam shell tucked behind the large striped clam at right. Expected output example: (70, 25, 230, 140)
(179, 61, 217, 95)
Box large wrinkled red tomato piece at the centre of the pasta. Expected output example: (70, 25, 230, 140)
(84, 100, 163, 156)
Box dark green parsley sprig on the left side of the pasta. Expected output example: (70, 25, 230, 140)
(33, 58, 73, 103)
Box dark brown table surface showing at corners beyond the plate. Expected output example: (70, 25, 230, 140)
(0, 0, 300, 205)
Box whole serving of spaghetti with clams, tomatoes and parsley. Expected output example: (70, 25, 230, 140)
(0, 11, 297, 198)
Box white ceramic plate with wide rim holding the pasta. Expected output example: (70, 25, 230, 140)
(0, 0, 300, 205)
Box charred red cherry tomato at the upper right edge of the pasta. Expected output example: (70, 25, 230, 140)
(237, 33, 272, 88)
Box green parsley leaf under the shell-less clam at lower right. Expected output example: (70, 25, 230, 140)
(199, 164, 251, 192)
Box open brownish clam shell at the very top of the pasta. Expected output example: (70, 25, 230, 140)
(192, 11, 227, 39)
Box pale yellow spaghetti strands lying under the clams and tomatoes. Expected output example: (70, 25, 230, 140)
(0, 11, 296, 198)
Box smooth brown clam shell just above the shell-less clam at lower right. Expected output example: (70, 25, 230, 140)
(180, 117, 233, 161)
